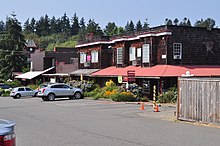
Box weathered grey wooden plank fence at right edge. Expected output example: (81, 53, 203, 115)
(177, 78, 220, 123)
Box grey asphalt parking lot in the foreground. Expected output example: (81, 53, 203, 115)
(0, 97, 220, 146)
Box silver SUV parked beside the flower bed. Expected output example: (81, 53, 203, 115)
(37, 83, 84, 101)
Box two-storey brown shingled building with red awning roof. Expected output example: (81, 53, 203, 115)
(76, 26, 220, 97)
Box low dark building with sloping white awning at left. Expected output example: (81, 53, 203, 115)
(16, 47, 78, 83)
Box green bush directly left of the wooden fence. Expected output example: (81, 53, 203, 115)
(158, 87, 178, 103)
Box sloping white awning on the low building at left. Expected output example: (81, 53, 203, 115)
(15, 67, 55, 80)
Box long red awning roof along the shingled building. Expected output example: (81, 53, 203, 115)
(92, 65, 220, 77)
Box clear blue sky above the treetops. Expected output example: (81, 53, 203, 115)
(0, 0, 220, 28)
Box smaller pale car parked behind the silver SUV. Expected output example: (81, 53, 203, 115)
(10, 87, 38, 99)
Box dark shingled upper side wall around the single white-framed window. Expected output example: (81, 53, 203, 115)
(167, 26, 220, 65)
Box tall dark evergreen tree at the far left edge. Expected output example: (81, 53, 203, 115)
(0, 13, 26, 79)
